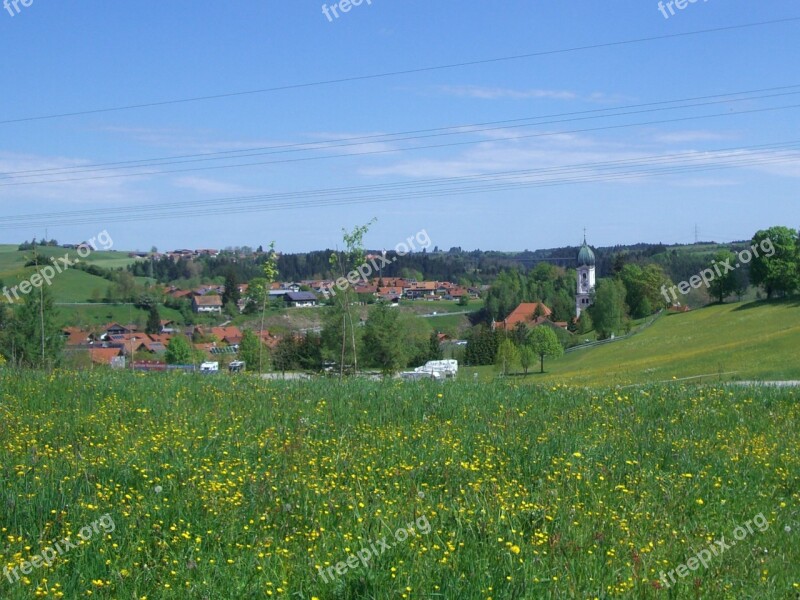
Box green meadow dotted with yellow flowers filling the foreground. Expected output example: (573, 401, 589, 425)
(0, 371, 800, 600)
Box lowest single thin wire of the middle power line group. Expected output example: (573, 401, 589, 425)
(0, 99, 800, 187)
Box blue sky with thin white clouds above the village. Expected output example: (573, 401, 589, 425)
(0, 0, 800, 252)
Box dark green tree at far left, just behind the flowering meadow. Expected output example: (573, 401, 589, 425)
(6, 285, 64, 369)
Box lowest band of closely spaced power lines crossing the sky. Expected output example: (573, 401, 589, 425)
(0, 140, 800, 229)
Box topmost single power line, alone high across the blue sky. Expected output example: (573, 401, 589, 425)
(0, 17, 800, 125)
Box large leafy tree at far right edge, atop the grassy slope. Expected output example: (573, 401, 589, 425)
(739, 227, 800, 298)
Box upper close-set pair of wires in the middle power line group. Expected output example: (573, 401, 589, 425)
(0, 84, 800, 180)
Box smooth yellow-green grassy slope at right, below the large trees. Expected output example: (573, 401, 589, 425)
(462, 300, 800, 385)
